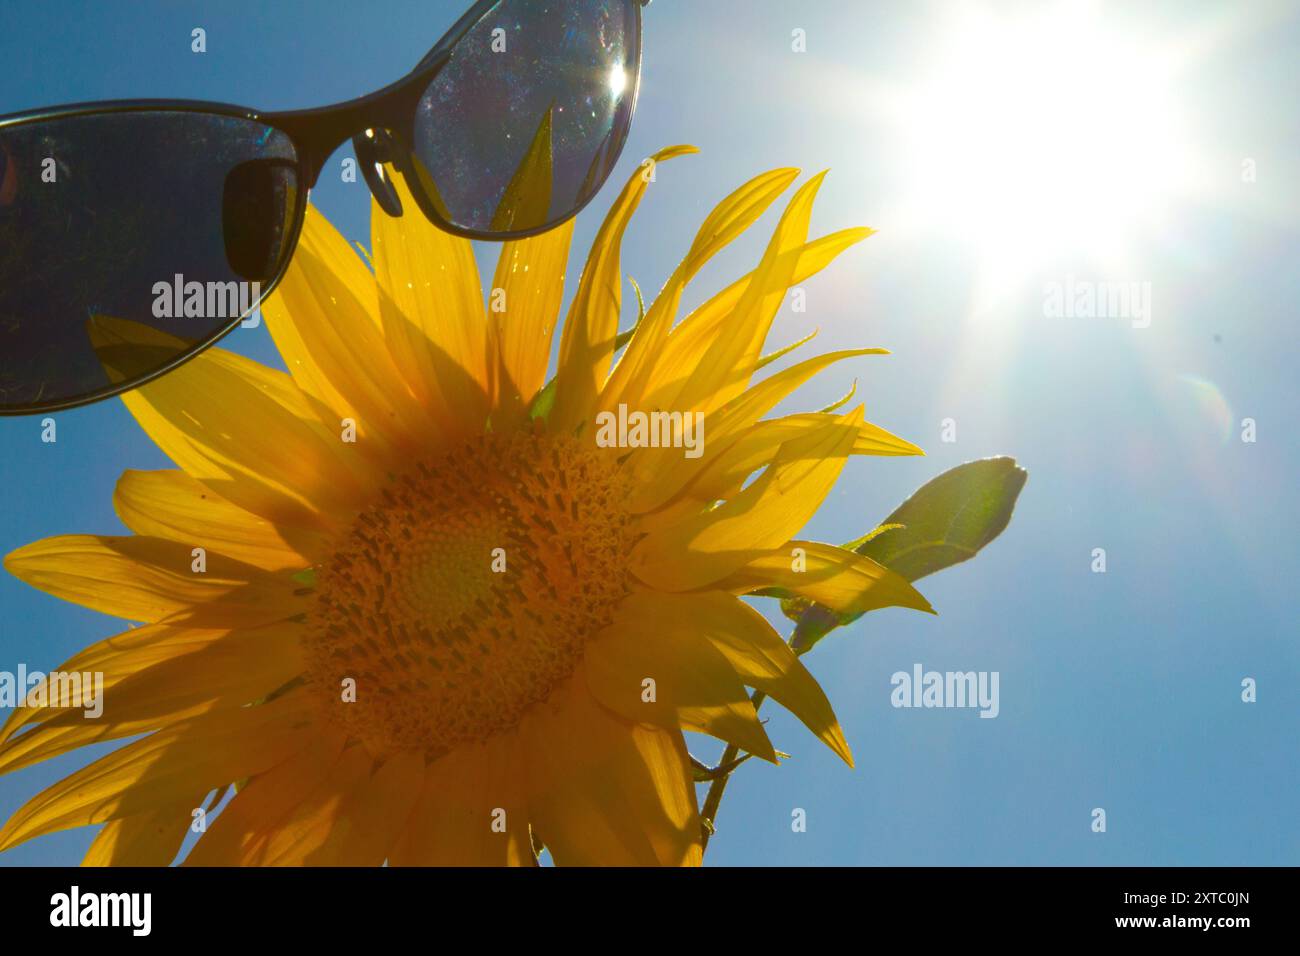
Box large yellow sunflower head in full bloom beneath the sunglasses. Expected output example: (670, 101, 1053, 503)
(0, 147, 930, 865)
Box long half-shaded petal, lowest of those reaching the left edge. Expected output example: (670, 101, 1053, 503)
(0, 693, 312, 851)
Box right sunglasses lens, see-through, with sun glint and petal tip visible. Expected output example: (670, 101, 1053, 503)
(413, 0, 641, 233)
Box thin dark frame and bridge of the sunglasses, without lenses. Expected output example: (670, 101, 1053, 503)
(0, 0, 650, 418)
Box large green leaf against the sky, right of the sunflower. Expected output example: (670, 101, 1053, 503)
(781, 458, 1028, 652)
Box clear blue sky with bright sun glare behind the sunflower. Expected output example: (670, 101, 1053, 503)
(0, 0, 1300, 865)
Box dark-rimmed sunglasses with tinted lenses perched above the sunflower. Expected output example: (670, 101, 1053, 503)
(0, 0, 649, 415)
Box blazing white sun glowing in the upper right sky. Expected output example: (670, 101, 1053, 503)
(894, 4, 1196, 299)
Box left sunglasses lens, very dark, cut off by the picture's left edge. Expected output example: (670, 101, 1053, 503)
(0, 111, 298, 411)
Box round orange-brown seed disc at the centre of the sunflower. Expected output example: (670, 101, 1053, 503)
(306, 433, 633, 756)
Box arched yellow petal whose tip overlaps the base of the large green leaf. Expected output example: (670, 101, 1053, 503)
(718, 541, 933, 614)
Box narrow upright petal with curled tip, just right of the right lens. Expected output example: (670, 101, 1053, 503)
(550, 146, 698, 433)
